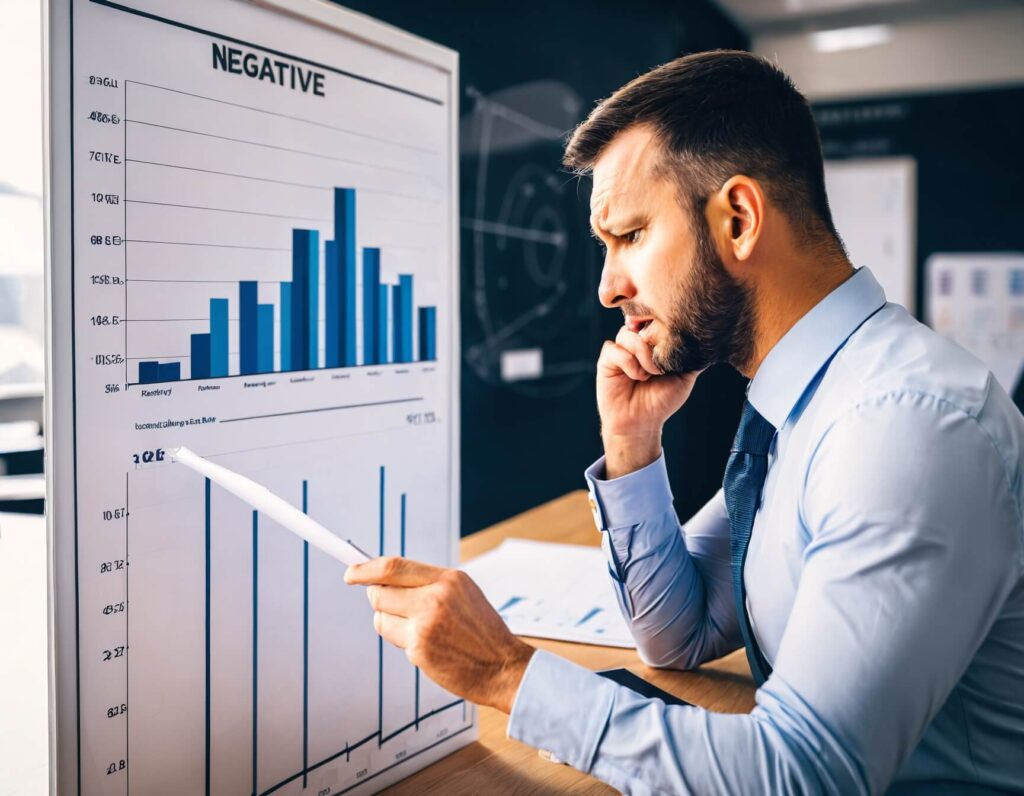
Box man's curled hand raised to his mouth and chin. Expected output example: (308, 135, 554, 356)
(597, 326, 697, 478)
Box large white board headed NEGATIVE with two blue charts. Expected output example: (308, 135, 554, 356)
(47, 0, 468, 796)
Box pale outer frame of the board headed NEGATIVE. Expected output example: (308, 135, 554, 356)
(42, 0, 460, 794)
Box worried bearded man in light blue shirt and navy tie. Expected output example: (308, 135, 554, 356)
(347, 52, 1024, 794)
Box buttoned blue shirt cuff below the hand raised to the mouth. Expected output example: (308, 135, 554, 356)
(584, 453, 672, 531)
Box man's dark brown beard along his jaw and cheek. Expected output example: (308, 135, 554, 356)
(653, 212, 755, 373)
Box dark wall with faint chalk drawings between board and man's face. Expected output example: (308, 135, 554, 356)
(331, 0, 748, 533)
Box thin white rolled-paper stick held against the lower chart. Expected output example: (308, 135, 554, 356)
(171, 448, 370, 565)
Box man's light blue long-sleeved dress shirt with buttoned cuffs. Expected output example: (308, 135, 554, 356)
(509, 268, 1024, 794)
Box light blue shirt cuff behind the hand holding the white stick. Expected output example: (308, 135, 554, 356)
(508, 650, 615, 773)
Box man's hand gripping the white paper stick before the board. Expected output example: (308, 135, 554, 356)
(345, 557, 534, 713)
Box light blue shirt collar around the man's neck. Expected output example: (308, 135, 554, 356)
(746, 268, 886, 428)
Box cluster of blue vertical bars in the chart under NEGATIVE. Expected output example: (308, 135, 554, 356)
(137, 187, 437, 384)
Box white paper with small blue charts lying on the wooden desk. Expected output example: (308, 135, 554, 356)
(462, 539, 636, 647)
